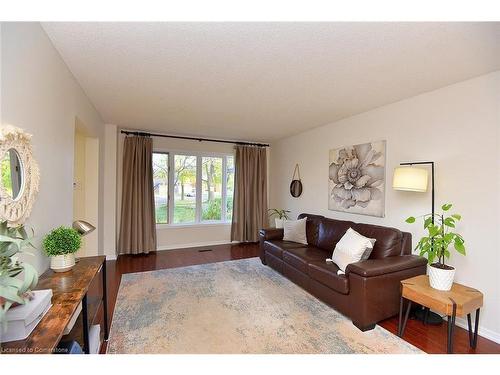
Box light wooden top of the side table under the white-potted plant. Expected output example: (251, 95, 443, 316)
(401, 275, 483, 316)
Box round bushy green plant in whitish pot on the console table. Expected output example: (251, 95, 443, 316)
(43, 226, 82, 272)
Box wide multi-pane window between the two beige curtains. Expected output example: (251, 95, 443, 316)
(153, 152, 234, 224)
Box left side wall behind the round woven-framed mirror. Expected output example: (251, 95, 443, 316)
(1, 22, 104, 271)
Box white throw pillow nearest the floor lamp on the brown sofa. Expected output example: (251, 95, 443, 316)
(332, 228, 376, 272)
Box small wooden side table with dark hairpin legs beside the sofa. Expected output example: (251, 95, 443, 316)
(398, 275, 483, 353)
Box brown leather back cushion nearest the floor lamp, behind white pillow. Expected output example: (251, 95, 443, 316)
(352, 224, 403, 259)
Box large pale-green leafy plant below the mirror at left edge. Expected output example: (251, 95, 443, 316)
(0, 221, 38, 333)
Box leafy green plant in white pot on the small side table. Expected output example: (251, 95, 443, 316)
(406, 204, 465, 291)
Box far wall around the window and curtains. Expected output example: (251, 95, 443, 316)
(116, 133, 234, 254)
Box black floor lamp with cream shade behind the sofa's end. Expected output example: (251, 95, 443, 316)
(392, 161, 443, 324)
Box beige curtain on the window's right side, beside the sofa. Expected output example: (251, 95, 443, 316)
(231, 146, 267, 242)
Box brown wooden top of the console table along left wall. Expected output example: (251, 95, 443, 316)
(0, 256, 106, 354)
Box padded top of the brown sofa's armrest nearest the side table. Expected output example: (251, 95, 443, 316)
(346, 255, 427, 277)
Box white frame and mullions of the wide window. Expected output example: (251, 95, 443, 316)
(153, 149, 235, 229)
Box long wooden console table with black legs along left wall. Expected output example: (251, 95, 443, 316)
(0, 256, 108, 354)
